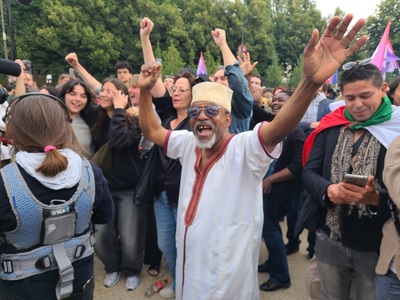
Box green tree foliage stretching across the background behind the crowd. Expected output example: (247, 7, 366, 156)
(0, 0, 400, 85)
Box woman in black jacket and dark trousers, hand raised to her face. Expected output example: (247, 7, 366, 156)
(88, 78, 145, 290)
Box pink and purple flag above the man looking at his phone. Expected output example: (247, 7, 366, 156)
(371, 20, 400, 76)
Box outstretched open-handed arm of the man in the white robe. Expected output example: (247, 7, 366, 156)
(261, 14, 368, 151)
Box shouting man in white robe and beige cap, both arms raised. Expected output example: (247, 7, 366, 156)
(139, 15, 367, 300)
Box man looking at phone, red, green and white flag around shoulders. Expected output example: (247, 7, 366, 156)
(303, 59, 400, 299)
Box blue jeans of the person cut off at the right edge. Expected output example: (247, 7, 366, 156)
(375, 270, 400, 300)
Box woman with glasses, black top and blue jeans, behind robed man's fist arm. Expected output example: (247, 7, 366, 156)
(140, 72, 195, 298)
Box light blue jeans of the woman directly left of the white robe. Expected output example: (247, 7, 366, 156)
(154, 192, 178, 291)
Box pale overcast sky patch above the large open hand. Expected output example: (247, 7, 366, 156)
(315, 0, 381, 19)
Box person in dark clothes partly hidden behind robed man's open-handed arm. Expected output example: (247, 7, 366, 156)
(259, 90, 305, 291)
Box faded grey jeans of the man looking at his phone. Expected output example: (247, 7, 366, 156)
(315, 231, 378, 300)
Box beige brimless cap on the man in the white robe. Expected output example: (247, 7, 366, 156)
(192, 82, 233, 112)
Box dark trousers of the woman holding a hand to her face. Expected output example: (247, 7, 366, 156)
(94, 189, 146, 276)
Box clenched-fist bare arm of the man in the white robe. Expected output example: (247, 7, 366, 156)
(139, 62, 168, 147)
